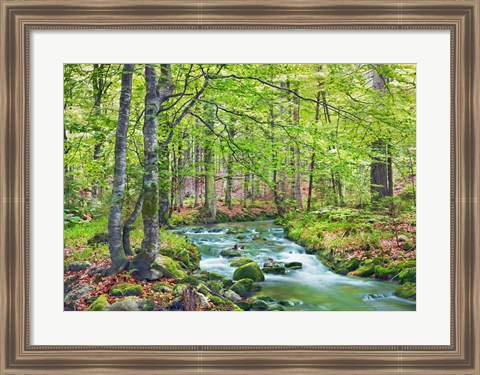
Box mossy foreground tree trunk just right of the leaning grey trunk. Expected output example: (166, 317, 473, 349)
(133, 64, 173, 279)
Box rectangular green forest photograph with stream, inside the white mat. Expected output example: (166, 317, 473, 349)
(63, 63, 417, 314)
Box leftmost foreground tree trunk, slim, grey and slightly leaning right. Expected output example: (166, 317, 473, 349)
(108, 64, 133, 273)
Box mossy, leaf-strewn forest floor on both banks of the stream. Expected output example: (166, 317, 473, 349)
(64, 201, 416, 311)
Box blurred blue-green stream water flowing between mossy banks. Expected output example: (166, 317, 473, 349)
(174, 221, 416, 311)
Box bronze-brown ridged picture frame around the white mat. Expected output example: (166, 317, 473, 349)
(0, 0, 480, 375)
